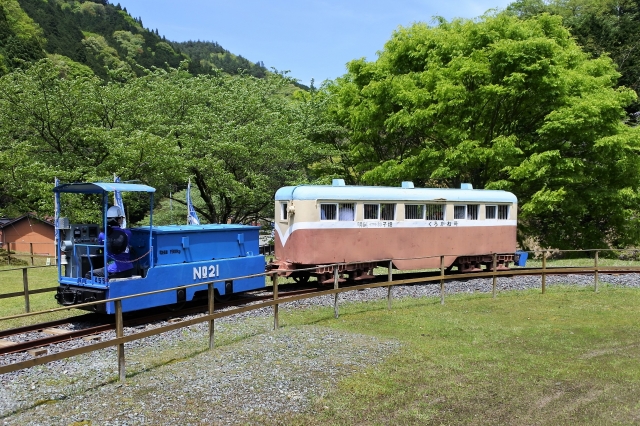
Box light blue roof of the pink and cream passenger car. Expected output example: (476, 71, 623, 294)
(275, 185, 518, 203)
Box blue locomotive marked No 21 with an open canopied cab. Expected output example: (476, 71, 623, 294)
(54, 182, 265, 314)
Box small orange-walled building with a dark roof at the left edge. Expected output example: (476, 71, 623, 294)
(2, 217, 56, 256)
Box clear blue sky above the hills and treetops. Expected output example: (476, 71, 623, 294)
(117, 0, 513, 86)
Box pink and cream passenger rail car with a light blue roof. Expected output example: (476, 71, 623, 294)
(271, 179, 517, 281)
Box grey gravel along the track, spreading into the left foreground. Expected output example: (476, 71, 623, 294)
(0, 274, 640, 425)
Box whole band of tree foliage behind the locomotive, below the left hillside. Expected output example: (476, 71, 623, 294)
(0, 60, 326, 223)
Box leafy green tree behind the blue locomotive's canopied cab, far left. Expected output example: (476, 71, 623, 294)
(0, 58, 164, 222)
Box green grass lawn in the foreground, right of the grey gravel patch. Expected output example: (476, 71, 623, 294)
(272, 285, 640, 425)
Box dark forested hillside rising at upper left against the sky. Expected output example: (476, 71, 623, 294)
(0, 0, 266, 79)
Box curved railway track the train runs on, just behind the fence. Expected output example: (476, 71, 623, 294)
(0, 267, 640, 355)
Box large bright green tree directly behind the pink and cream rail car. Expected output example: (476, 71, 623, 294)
(327, 13, 640, 248)
